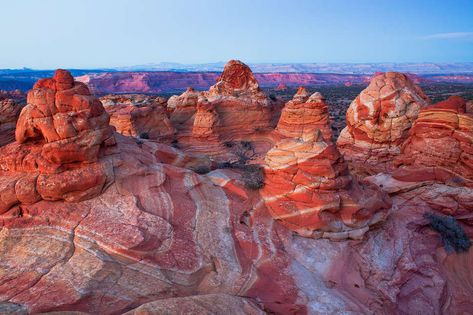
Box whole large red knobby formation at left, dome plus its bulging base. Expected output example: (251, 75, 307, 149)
(0, 70, 115, 213)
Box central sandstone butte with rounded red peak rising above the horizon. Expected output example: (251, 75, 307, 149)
(167, 60, 274, 160)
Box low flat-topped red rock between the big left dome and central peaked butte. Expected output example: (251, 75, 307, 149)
(101, 95, 175, 139)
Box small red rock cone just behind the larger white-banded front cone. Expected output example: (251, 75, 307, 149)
(276, 88, 333, 142)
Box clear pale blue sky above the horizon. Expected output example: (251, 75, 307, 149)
(0, 0, 473, 69)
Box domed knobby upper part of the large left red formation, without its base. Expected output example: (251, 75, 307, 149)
(15, 70, 113, 164)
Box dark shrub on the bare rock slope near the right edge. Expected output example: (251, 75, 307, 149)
(425, 213, 471, 253)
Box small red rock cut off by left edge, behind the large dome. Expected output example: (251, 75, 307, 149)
(0, 98, 21, 147)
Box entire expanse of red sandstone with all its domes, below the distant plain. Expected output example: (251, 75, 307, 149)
(0, 61, 473, 314)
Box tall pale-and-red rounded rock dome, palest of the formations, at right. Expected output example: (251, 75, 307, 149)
(337, 72, 429, 174)
